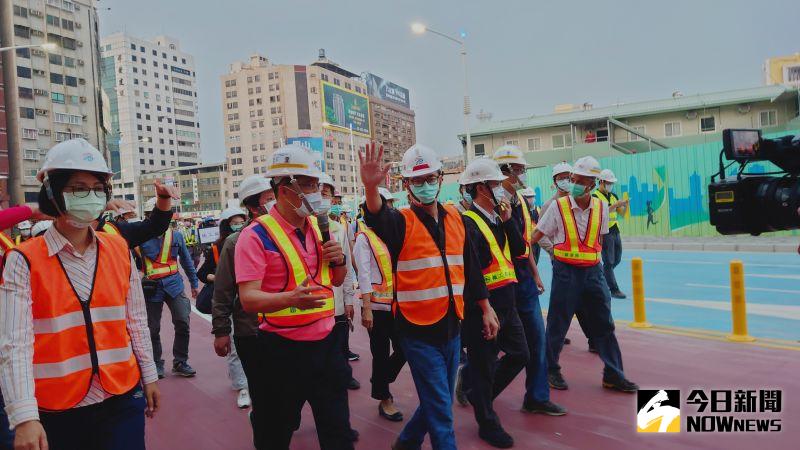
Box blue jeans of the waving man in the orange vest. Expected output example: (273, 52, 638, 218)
(399, 336, 461, 450)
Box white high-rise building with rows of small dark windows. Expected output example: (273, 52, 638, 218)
(100, 33, 200, 203)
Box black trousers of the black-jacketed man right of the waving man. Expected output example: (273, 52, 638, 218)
(463, 307, 530, 430)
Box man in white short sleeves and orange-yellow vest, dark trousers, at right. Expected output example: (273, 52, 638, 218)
(533, 156, 639, 393)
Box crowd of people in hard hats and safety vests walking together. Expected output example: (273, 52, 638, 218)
(0, 139, 638, 450)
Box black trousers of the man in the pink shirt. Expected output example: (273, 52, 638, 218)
(255, 332, 353, 450)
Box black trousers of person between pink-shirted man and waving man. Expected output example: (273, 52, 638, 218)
(369, 311, 406, 400)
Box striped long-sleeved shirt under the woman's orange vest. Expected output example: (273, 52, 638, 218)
(0, 227, 158, 428)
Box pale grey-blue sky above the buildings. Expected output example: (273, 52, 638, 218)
(98, 0, 800, 162)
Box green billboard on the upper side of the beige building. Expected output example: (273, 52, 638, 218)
(322, 81, 370, 137)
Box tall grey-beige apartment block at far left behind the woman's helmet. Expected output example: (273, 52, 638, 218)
(0, 0, 105, 204)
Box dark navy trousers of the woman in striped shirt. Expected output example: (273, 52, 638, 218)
(39, 386, 147, 450)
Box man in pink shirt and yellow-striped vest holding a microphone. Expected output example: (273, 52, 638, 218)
(235, 144, 356, 449)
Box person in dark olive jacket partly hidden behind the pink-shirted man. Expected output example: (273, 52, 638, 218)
(211, 175, 275, 448)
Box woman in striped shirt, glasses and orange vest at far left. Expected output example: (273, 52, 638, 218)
(0, 139, 160, 450)
